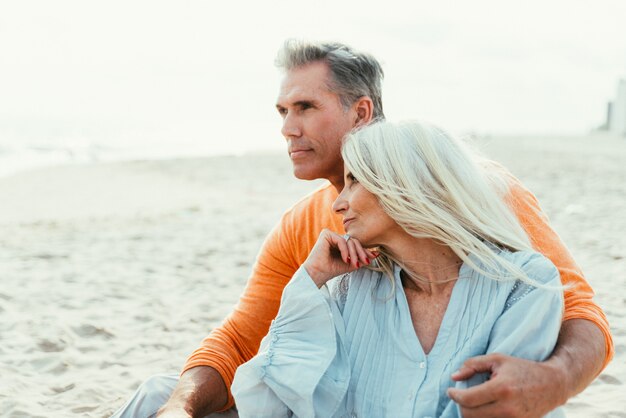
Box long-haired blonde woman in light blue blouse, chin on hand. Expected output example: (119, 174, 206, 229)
(232, 122, 563, 417)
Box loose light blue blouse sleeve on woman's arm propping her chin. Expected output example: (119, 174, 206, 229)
(232, 268, 350, 418)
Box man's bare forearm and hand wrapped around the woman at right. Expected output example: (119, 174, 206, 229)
(448, 319, 605, 418)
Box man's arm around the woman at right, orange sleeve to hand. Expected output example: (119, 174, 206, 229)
(450, 167, 613, 418)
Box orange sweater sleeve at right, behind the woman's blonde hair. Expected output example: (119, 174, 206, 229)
(500, 167, 614, 368)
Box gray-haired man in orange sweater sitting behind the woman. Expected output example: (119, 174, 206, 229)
(114, 40, 613, 418)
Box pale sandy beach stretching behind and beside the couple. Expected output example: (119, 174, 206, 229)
(0, 135, 626, 417)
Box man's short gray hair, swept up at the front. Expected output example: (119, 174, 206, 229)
(275, 39, 385, 120)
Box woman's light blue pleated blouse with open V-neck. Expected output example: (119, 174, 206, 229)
(232, 252, 563, 418)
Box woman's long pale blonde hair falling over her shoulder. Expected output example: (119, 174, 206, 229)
(342, 122, 544, 287)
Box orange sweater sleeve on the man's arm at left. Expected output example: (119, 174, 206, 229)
(181, 186, 341, 410)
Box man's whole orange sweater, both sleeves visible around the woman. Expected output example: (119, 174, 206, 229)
(183, 172, 613, 408)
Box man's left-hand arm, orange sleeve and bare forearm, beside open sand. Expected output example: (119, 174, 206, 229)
(158, 185, 342, 418)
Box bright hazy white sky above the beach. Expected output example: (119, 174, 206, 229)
(0, 0, 626, 153)
